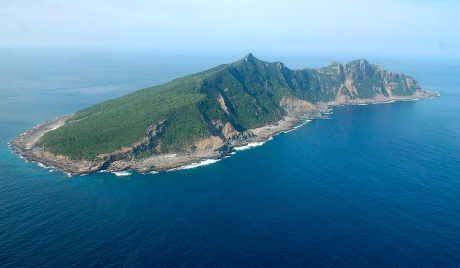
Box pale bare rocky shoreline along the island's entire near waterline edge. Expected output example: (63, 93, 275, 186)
(9, 91, 439, 176)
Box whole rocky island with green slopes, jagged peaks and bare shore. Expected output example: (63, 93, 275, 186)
(10, 53, 436, 175)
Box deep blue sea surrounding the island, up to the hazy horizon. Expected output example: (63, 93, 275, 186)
(0, 49, 460, 267)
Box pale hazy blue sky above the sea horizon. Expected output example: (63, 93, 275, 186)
(0, 0, 460, 56)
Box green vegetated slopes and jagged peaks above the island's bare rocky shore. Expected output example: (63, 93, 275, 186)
(39, 54, 420, 160)
